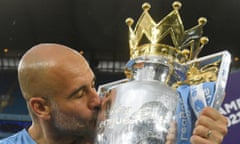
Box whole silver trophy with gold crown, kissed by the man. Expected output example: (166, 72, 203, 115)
(95, 2, 231, 144)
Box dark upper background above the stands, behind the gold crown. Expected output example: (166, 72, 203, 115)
(0, 0, 240, 66)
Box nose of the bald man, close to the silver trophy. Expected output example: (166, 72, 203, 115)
(88, 89, 101, 110)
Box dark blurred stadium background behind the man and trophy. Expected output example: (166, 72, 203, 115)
(0, 0, 240, 142)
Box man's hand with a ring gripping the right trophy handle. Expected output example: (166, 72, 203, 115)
(191, 107, 228, 144)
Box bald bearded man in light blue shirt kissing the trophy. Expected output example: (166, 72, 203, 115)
(0, 44, 227, 144)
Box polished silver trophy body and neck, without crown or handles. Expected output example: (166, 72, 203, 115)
(97, 60, 178, 144)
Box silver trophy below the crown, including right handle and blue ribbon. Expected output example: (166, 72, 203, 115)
(95, 51, 231, 144)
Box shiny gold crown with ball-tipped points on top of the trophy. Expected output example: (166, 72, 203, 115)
(126, 1, 208, 63)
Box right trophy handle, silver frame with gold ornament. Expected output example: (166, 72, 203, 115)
(183, 51, 231, 109)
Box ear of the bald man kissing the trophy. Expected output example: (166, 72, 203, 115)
(28, 97, 50, 120)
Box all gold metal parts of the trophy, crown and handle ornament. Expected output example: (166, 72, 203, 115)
(125, 1, 221, 88)
